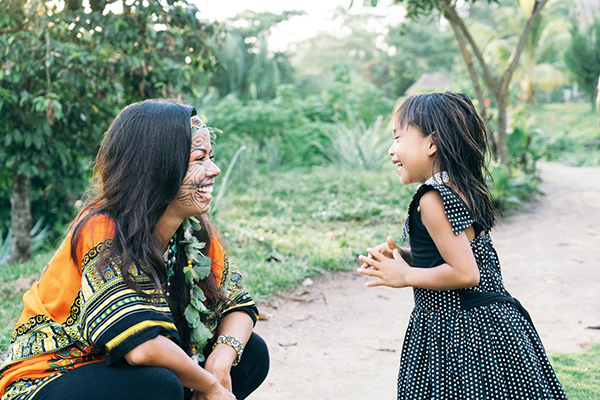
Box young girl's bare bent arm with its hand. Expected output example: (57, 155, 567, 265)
(358, 190, 479, 290)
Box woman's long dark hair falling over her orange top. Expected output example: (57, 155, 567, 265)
(71, 100, 219, 352)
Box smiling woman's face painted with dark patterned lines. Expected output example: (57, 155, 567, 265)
(173, 128, 221, 217)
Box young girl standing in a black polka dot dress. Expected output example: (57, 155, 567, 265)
(358, 92, 566, 400)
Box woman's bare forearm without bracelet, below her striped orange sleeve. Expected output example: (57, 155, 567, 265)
(125, 335, 235, 400)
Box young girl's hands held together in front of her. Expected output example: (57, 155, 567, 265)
(357, 247, 411, 288)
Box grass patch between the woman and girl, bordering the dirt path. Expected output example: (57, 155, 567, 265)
(217, 167, 414, 300)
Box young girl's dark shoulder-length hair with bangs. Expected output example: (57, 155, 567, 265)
(393, 92, 496, 234)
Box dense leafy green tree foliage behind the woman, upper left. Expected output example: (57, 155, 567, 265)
(0, 0, 216, 241)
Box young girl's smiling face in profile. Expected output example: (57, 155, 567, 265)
(388, 124, 436, 185)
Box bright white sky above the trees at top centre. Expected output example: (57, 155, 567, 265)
(194, 0, 404, 51)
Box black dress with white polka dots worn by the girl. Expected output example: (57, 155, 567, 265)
(398, 174, 566, 400)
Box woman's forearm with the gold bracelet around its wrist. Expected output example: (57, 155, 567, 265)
(205, 311, 254, 390)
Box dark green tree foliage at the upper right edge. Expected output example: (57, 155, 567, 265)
(565, 17, 600, 108)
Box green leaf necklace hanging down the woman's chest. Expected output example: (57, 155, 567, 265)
(165, 217, 214, 362)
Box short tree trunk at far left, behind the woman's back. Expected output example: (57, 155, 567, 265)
(8, 170, 32, 263)
